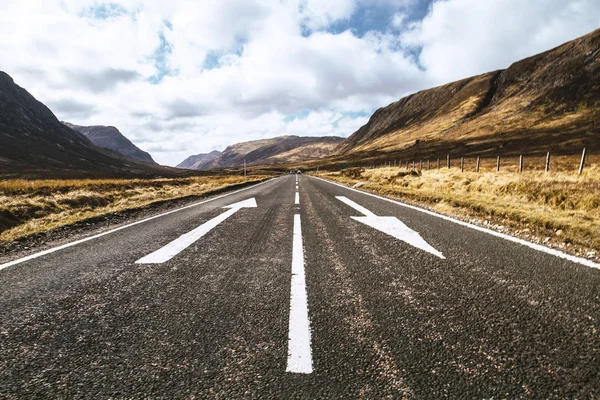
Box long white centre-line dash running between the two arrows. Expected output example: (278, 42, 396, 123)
(286, 214, 313, 374)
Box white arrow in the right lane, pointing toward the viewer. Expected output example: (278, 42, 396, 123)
(335, 196, 446, 259)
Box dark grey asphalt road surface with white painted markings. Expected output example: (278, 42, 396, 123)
(0, 175, 600, 399)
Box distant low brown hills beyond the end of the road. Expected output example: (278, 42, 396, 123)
(179, 136, 344, 170)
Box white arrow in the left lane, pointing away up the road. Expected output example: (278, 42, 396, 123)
(135, 197, 256, 264)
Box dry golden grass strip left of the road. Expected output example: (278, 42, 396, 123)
(0, 175, 266, 243)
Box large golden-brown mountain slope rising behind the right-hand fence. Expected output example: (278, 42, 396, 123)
(334, 30, 600, 160)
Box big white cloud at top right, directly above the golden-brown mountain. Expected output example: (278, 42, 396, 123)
(402, 0, 600, 84)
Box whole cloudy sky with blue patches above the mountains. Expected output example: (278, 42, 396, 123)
(0, 0, 600, 166)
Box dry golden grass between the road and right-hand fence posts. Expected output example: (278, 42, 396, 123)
(319, 153, 600, 259)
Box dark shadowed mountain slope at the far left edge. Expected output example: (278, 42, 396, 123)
(0, 71, 181, 178)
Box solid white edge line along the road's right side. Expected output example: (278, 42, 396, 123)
(313, 176, 600, 269)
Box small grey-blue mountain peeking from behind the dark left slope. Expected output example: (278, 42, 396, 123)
(63, 121, 156, 164)
